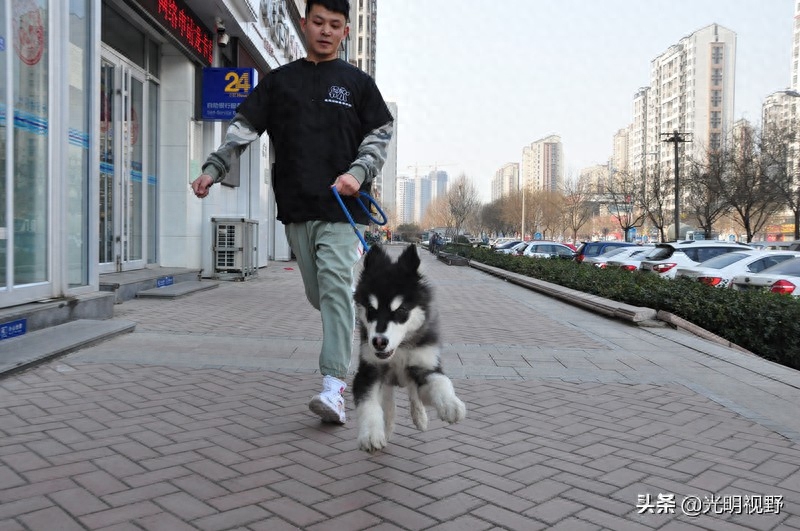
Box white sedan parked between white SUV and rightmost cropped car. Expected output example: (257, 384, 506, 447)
(675, 251, 800, 288)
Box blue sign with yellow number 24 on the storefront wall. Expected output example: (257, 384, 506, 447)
(201, 68, 256, 120)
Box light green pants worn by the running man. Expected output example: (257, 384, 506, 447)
(286, 221, 363, 380)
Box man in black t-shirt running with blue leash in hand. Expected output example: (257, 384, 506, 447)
(192, 0, 393, 424)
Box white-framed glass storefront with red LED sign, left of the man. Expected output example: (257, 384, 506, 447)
(0, 0, 302, 308)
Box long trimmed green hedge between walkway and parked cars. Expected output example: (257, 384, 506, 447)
(458, 248, 800, 369)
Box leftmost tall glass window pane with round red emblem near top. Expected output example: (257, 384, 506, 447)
(11, 0, 50, 284)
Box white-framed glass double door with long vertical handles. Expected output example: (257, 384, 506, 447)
(99, 48, 149, 273)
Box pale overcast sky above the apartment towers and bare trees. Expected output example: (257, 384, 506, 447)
(376, 0, 794, 201)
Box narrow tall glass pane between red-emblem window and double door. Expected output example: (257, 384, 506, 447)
(65, 0, 91, 287)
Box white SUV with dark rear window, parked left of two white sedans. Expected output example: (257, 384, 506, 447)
(639, 240, 753, 278)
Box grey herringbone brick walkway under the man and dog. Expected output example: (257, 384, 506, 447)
(0, 249, 800, 531)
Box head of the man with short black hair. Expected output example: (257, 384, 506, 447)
(300, 0, 350, 62)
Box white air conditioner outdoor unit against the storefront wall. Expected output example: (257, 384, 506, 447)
(211, 218, 258, 280)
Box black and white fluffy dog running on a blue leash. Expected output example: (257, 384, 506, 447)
(353, 245, 466, 452)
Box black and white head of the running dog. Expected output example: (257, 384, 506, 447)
(355, 245, 430, 363)
